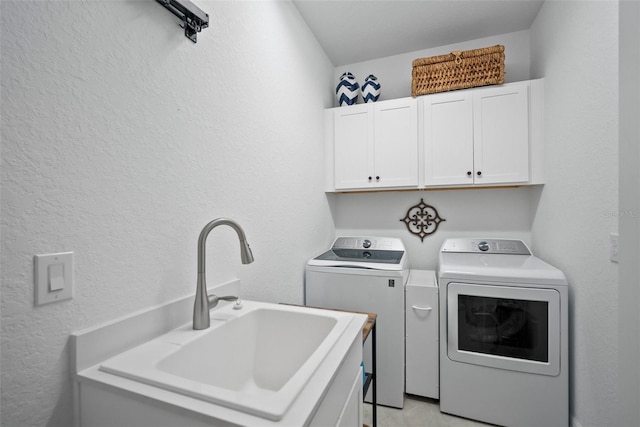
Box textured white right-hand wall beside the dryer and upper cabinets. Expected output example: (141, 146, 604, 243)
(530, 1, 618, 427)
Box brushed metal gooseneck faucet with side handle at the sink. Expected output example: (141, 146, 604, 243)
(193, 218, 253, 330)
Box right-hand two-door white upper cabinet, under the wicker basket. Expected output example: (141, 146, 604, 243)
(421, 82, 530, 187)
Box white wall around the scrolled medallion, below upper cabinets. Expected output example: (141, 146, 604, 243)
(334, 188, 537, 270)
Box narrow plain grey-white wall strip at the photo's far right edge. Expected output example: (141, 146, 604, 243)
(618, 1, 640, 426)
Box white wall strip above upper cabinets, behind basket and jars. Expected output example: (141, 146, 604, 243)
(334, 30, 530, 106)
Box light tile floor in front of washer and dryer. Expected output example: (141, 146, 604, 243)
(364, 395, 490, 427)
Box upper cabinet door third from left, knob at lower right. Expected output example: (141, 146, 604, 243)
(422, 92, 473, 186)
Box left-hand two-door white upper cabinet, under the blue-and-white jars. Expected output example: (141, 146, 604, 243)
(332, 98, 418, 190)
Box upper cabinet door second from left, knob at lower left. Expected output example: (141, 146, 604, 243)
(373, 98, 418, 188)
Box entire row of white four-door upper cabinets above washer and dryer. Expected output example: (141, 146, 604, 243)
(325, 79, 544, 191)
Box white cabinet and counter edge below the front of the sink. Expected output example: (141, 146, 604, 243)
(76, 336, 363, 427)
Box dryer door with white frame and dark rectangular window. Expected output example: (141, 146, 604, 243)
(446, 283, 561, 375)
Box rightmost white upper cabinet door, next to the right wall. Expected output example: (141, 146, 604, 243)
(473, 84, 529, 185)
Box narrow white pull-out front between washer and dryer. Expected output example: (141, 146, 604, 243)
(405, 285, 440, 399)
